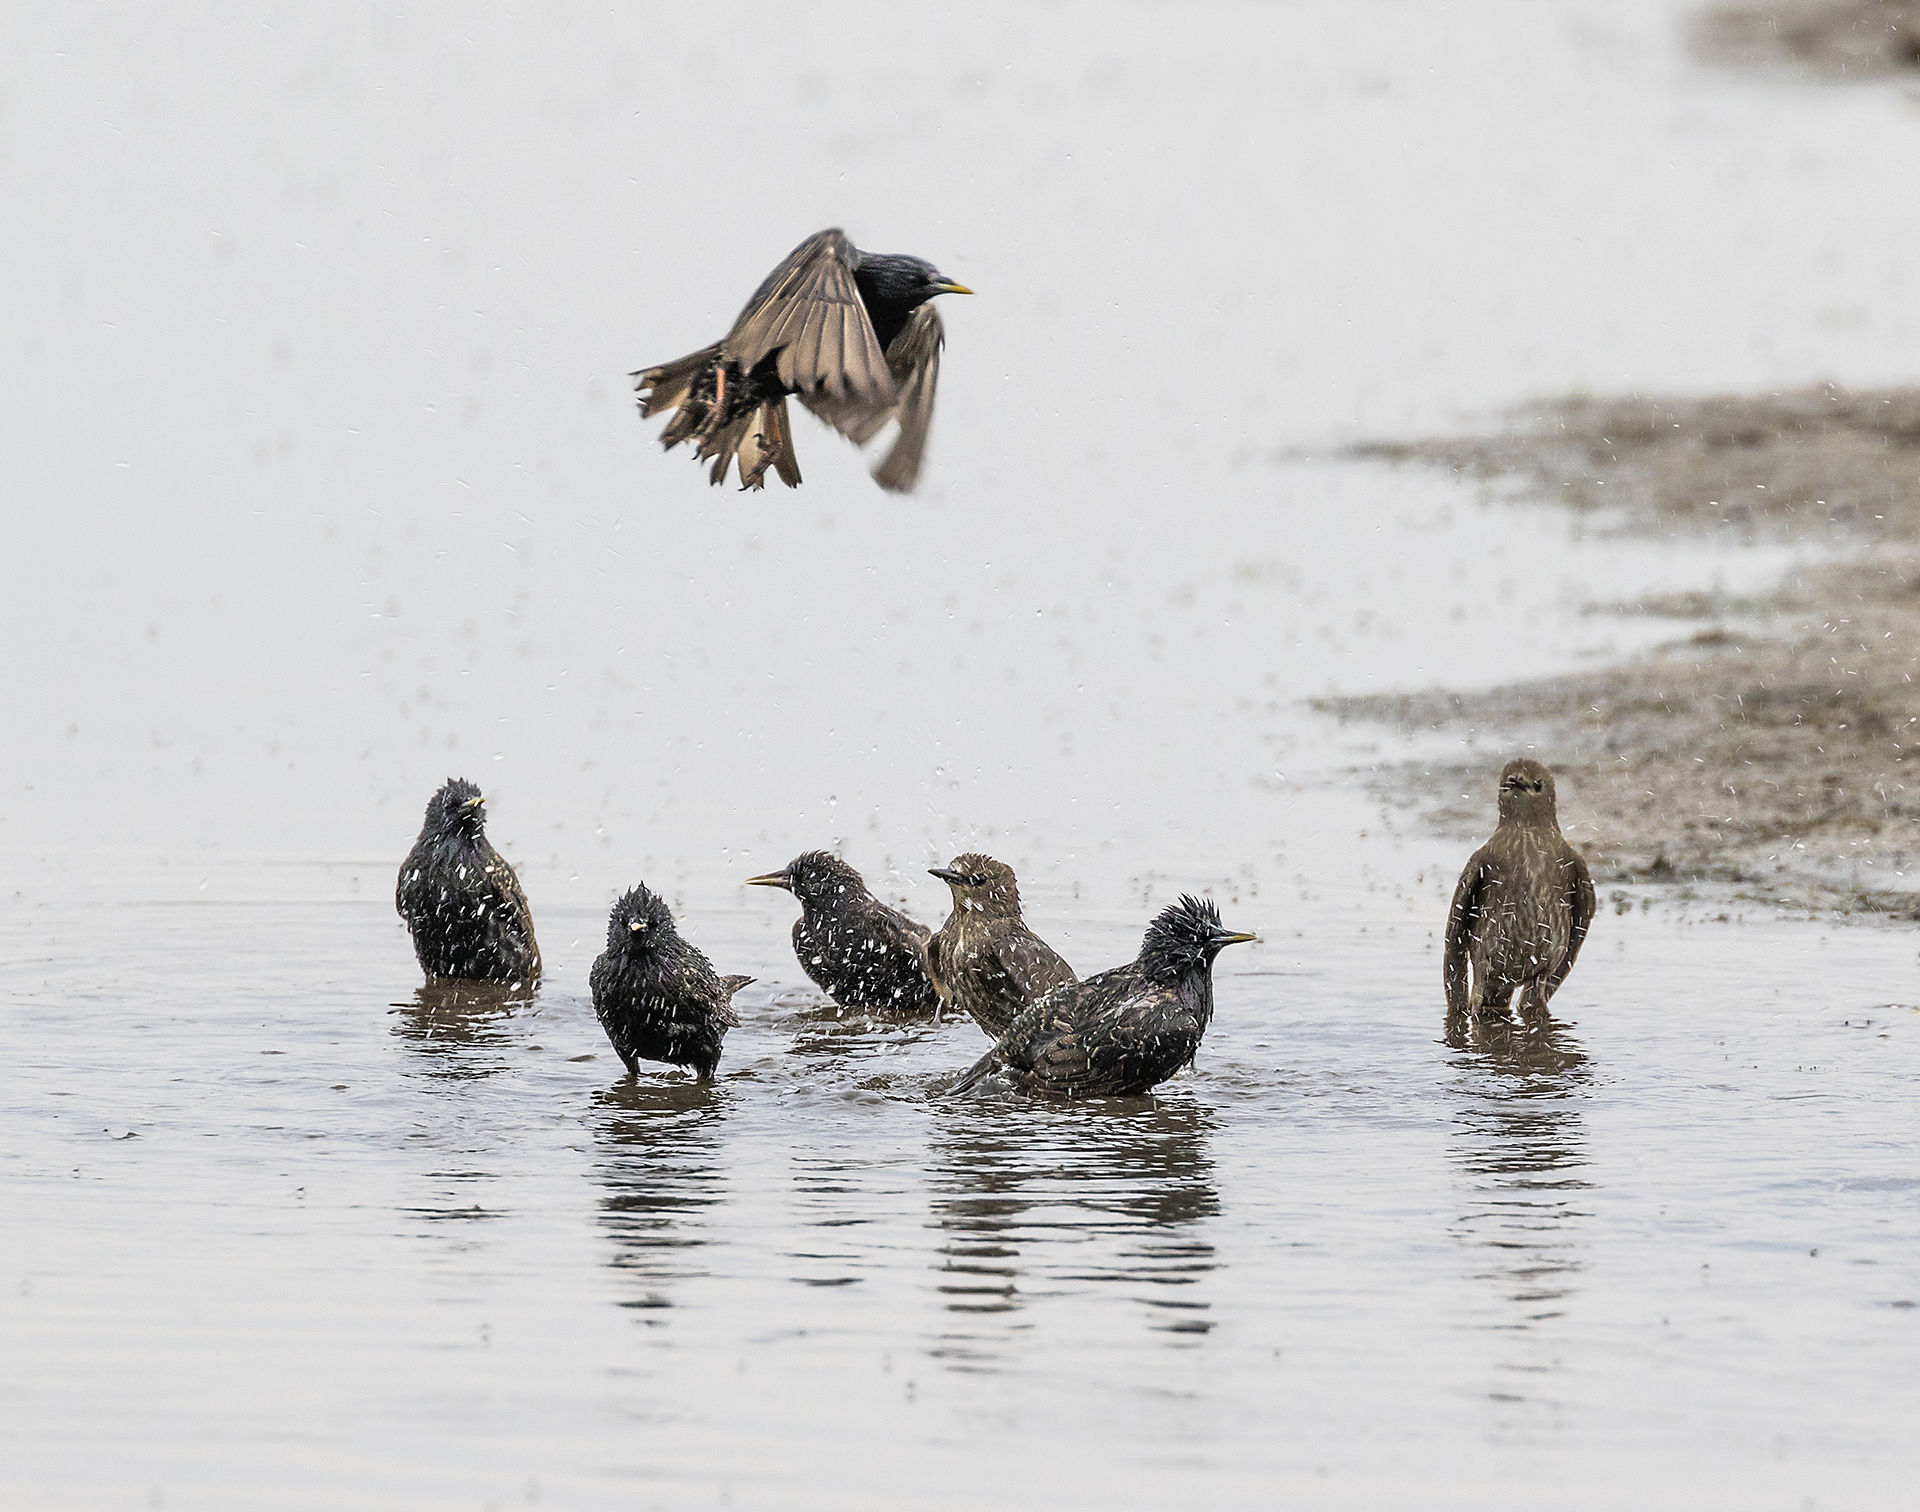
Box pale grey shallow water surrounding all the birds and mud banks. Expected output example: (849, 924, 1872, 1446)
(0, 4, 1920, 1508)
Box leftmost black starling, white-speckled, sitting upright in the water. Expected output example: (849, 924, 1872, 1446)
(394, 777, 540, 986)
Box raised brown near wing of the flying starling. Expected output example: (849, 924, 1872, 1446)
(720, 230, 893, 407)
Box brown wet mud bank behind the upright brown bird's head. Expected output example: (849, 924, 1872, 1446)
(1317, 386, 1920, 915)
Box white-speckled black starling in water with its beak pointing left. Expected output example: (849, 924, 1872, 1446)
(747, 850, 941, 1015)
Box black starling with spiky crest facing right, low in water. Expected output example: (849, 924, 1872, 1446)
(950, 896, 1254, 1098)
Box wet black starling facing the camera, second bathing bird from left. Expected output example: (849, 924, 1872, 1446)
(588, 883, 753, 1082)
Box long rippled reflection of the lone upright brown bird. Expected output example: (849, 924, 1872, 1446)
(1446, 1011, 1594, 1403)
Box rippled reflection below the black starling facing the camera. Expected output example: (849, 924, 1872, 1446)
(593, 1080, 726, 1326)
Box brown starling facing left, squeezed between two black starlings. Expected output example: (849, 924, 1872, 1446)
(927, 856, 1073, 1040)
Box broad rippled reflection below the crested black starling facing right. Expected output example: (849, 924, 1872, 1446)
(931, 1096, 1219, 1368)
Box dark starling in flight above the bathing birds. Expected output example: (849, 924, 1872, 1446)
(634, 230, 973, 493)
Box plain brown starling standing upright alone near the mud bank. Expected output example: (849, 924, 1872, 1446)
(1444, 758, 1594, 1013)
